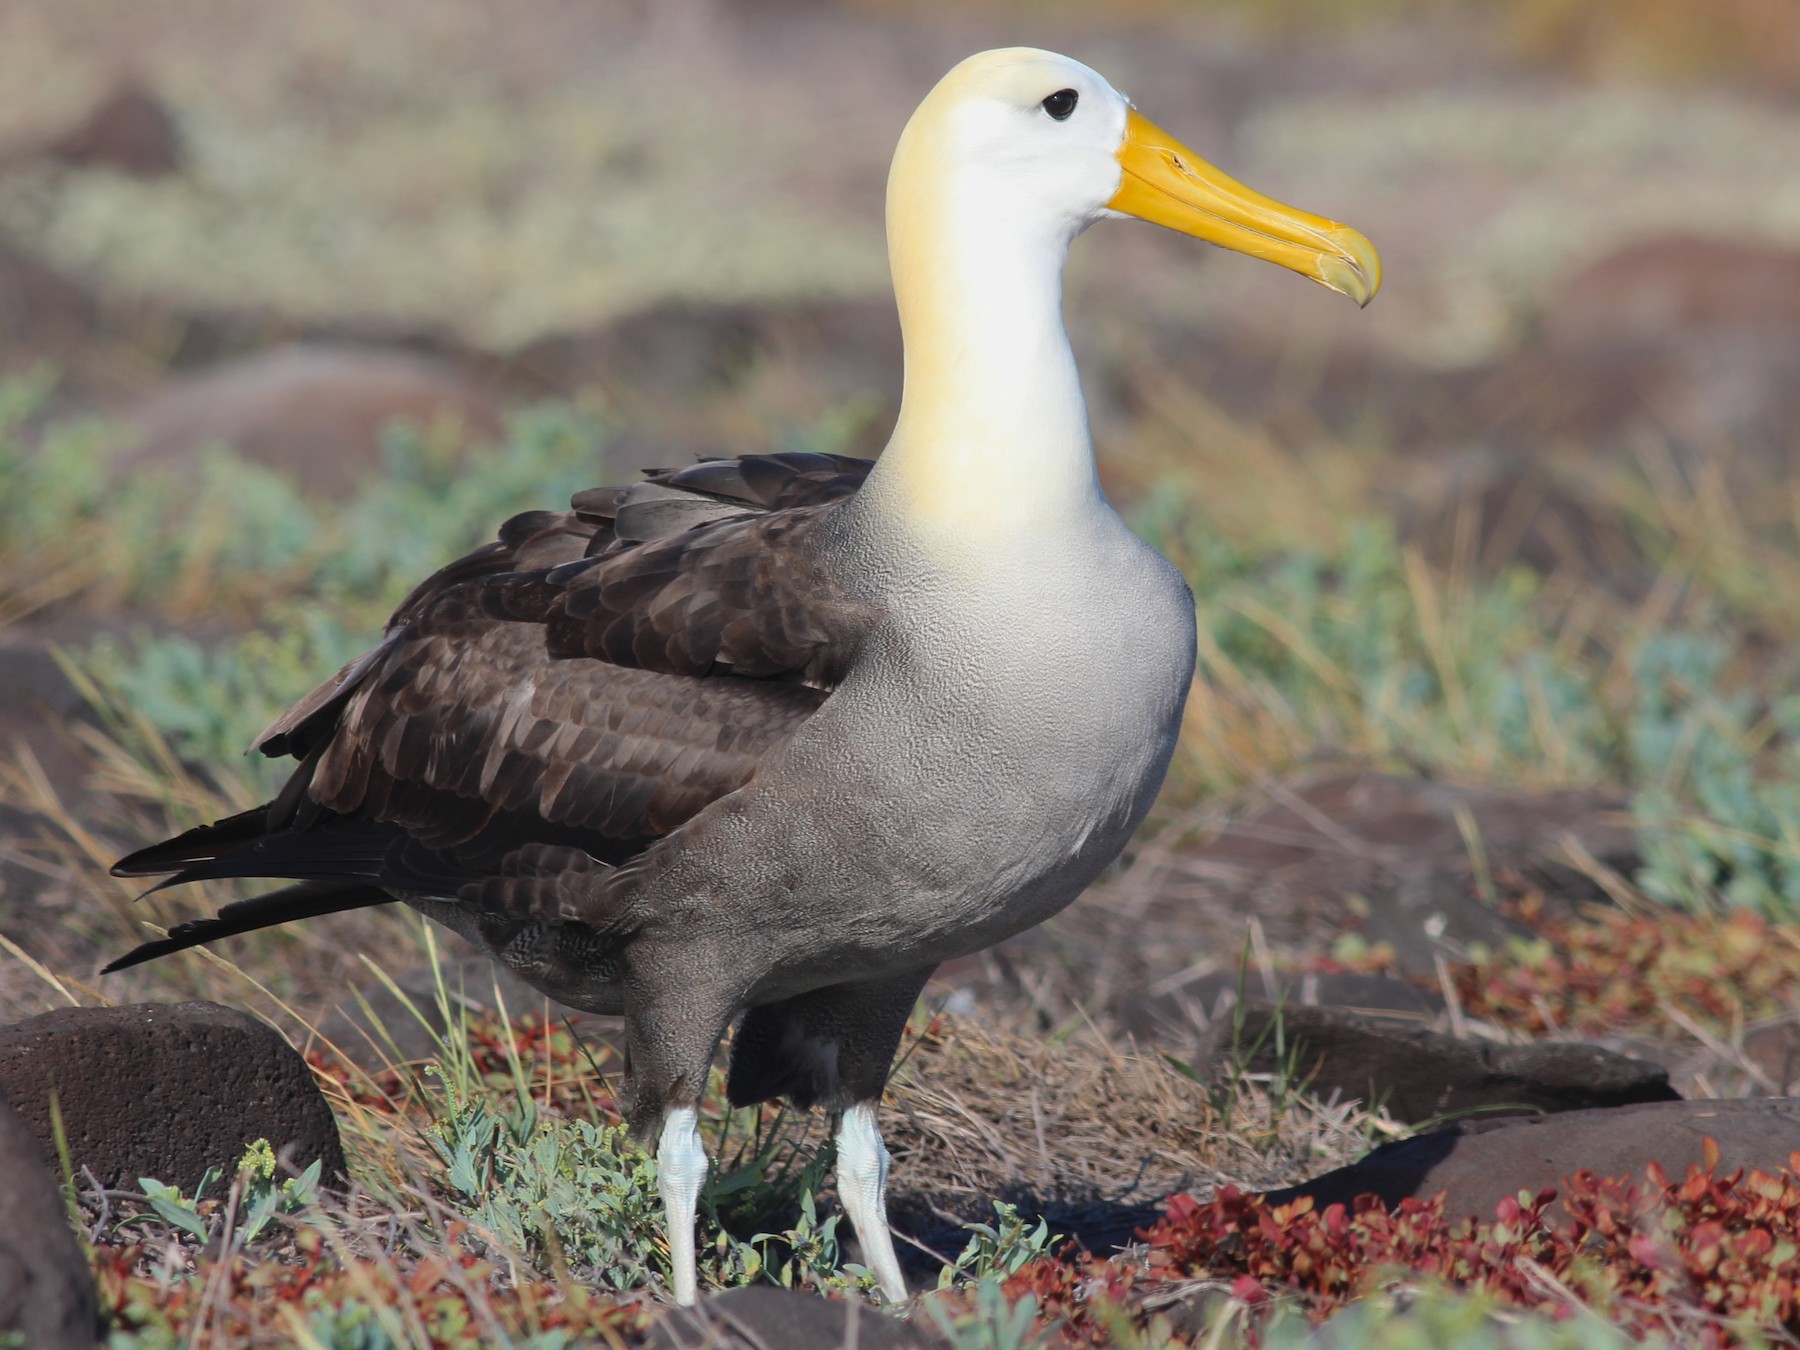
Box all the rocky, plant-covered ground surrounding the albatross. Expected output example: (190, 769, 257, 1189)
(0, 0, 1800, 1346)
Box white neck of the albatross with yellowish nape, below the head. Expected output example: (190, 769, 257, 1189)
(868, 162, 1102, 540)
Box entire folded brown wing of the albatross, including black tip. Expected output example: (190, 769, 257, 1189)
(119, 455, 869, 928)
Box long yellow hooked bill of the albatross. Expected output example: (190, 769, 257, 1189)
(1107, 108, 1381, 304)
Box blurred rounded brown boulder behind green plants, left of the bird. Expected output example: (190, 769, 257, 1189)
(126, 344, 500, 497)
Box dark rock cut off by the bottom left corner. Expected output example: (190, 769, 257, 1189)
(0, 1093, 99, 1350)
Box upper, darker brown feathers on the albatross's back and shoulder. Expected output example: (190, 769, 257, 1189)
(256, 454, 871, 758)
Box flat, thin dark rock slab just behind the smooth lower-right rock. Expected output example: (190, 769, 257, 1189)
(1206, 1001, 1681, 1123)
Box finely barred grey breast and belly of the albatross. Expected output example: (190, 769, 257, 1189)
(626, 513, 1193, 999)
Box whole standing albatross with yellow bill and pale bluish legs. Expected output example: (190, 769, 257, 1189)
(108, 49, 1381, 1303)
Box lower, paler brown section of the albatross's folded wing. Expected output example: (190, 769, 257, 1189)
(308, 587, 824, 866)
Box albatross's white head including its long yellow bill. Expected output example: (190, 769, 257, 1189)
(889, 47, 1381, 304)
